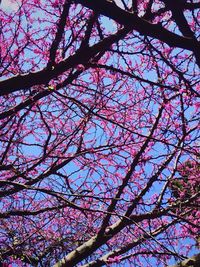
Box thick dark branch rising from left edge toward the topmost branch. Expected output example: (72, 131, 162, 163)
(0, 27, 130, 96)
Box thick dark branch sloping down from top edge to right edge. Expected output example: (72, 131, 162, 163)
(76, 0, 200, 66)
